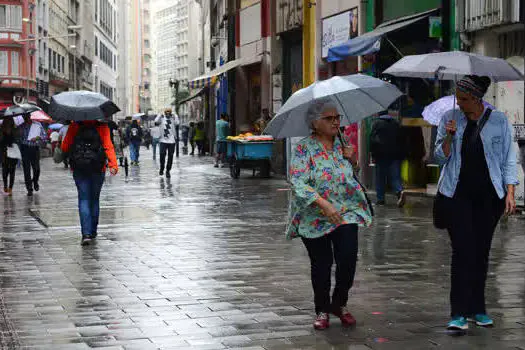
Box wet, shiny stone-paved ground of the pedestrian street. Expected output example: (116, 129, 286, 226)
(0, 149, 525, 350)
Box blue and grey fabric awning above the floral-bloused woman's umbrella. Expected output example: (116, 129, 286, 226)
(327, 8, 439, 62)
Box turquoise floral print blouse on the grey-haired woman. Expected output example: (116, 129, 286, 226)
(286, 136, 372, 239)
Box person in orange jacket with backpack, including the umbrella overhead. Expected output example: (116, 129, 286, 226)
(55, 91, 119, 246)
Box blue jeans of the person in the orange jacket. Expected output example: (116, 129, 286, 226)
(73, 172, 106, 236)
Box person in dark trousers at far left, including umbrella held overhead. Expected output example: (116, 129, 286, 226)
(8, 103, 46, 196)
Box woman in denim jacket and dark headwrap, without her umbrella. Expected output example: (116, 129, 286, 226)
(435, 76, 518, 331)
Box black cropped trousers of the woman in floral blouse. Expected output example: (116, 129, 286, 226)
(303, 225, 357, 314)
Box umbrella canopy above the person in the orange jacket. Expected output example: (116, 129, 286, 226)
(49, 91, 120, 121)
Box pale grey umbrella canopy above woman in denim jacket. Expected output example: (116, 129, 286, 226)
(383, 51, 523, 82)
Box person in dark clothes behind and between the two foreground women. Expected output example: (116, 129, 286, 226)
(370, 111, 405, 207)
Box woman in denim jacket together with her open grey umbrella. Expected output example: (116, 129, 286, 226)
(384, 51, 523, 334)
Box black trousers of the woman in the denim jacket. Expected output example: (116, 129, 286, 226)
(448, 193, 505, 317)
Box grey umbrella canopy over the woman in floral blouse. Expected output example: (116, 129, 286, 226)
(264, 74, 403, 138)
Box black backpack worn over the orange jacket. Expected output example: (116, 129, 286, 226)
(70, 125, 107, 173)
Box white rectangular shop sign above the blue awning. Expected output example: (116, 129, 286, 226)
(321, 7, 359, 58)
